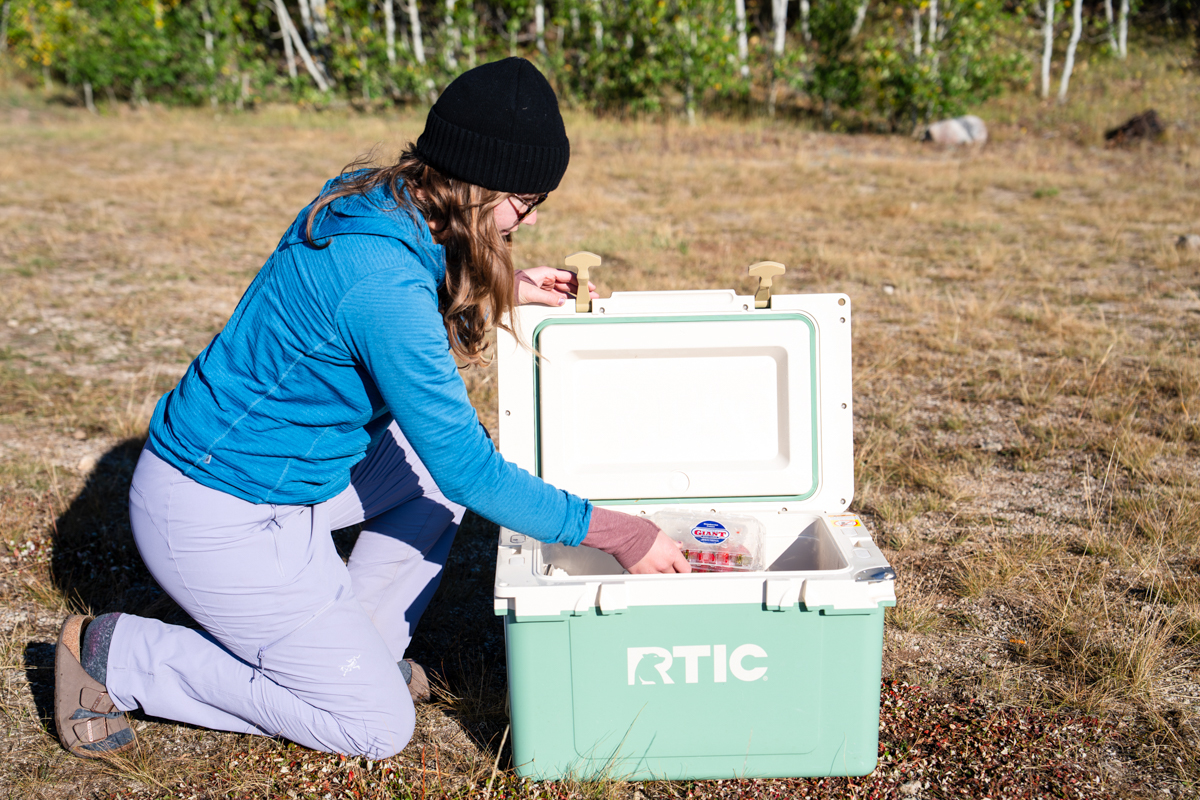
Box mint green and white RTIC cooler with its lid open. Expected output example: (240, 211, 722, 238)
(496, 257, 895, 780)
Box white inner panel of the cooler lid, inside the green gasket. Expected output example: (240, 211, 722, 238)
(533, 312, 821, 501)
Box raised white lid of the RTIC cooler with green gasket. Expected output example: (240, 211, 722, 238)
(498, 278, 853, 512)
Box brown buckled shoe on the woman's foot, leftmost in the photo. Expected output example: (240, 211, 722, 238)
(54, 614, 134, 758)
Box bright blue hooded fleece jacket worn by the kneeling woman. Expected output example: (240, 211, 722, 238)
(150, 179, 592, 545)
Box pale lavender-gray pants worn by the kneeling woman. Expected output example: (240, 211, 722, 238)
(114, 422, 463, 758)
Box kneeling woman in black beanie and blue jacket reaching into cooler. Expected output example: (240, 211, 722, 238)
(55, 59, 688, 758)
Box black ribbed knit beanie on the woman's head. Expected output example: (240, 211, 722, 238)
(416, 58, 571, 194)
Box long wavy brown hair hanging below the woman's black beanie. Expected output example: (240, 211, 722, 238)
(306, 144, 512, 366)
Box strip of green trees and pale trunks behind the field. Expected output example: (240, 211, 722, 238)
(0, 0, 1200, 125)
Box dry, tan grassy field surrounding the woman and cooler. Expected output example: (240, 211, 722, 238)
(0, 42, 1200, 799)
